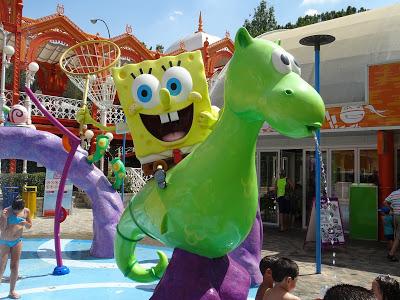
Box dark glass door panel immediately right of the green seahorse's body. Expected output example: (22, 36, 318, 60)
(258, 151, 279, 225)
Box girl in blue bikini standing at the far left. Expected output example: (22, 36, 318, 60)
(0, 198, 32, 299)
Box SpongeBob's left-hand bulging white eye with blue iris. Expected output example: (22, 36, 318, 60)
(132, 74, 160, 108)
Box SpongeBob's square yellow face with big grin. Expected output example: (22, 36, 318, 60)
(113, 51, 211, 158)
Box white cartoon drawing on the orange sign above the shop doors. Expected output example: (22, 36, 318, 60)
(325, 105, 386, 128)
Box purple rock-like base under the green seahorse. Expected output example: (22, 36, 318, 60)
(151, 249, 250, 300)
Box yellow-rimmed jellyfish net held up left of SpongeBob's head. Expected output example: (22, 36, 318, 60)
(60, 40, 121, 134)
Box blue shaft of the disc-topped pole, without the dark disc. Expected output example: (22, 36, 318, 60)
(314, 44, 321, 274)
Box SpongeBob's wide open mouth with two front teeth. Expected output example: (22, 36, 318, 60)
(140, 104, 193, 142)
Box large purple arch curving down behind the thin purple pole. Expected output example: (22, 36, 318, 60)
(0, 127, 123, 258)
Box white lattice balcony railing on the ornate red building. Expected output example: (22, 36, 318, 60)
(5, 90, 124, 124)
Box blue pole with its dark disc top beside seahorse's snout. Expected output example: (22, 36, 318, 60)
(299, 34, 335, 274)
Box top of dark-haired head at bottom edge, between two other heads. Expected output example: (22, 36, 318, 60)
(323, 284, 376, 300)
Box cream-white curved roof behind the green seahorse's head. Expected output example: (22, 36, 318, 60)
(211, 4, 400, 105)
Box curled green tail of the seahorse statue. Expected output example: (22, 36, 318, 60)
(114, 202, 168, 282)
